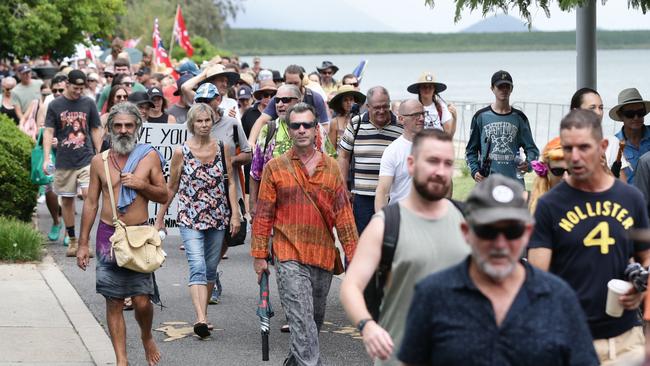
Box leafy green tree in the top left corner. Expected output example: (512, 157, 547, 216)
(0, 0, 124, 59)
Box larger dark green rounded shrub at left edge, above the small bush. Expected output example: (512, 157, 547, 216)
(0, 115, 38, 222)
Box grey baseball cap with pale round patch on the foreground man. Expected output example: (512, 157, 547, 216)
(465, 174, 533, 225)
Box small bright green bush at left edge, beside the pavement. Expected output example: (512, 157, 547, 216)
(0, 217, 44, 261)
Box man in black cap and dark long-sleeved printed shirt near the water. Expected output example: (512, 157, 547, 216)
(465, 70, 539, 186)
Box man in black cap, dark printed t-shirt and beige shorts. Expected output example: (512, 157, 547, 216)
(43, 70, 103, 257)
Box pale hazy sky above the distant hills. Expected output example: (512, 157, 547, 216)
(230, 0, 650, 33)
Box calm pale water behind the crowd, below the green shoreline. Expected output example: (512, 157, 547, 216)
(254, 50, 650, 106)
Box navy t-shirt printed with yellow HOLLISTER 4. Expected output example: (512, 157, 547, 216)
(528, 179, 650, 339)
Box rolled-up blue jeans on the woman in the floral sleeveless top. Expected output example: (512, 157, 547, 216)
(180, 227, 226, 286)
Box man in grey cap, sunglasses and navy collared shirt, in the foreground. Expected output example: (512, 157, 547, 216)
(398, 174, 598, 366)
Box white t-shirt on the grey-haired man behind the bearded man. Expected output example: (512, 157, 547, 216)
(379, 136, 413, 203)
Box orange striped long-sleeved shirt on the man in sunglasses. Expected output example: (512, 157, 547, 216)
(251, 149, 358, 271)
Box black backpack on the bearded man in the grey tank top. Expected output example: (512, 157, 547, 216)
(363, 199, 465, 321)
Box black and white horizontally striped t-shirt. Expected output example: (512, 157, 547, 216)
(339, 112, 404, 196)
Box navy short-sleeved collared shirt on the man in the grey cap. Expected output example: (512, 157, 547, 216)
(398, 257, 599, 366)
